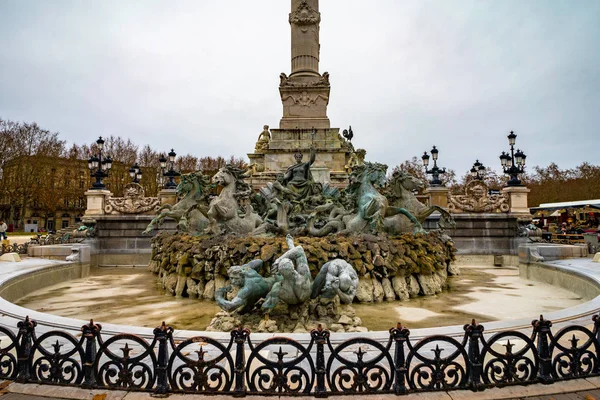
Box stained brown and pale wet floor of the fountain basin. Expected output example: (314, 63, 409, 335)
(16, 265, 587, 330)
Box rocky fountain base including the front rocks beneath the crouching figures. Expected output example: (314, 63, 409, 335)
(150, 232, 458, 332)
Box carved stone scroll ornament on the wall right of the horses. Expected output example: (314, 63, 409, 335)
(448, 180, 510, 213)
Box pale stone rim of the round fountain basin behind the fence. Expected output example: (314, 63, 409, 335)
(0, 253, 600, 342)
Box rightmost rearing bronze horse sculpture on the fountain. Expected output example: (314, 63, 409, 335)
(383, 171, 456, 234)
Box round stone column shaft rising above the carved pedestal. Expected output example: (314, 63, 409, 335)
(289, 0, 321, 76)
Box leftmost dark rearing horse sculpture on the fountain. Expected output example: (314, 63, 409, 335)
(142, 171, 210, 234)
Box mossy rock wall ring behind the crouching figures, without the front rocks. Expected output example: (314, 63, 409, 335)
(149, 232, 458, 302)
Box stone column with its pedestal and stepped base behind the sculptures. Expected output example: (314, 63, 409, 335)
(248, 0, 364, 189)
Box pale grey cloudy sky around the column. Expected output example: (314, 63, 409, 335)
(0, 0, 600, 174)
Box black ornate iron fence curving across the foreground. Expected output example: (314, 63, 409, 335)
(0, 315, 600, 397)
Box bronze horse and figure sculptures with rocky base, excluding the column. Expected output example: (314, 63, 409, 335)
(145, 158, 457, 332)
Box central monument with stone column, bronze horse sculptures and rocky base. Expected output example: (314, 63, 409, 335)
(139, 0, 457, 332)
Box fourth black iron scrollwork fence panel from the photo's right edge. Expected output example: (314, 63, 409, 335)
(326, 338, 394, 393)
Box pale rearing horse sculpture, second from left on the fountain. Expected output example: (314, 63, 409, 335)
(206, 164, 262, 234)
